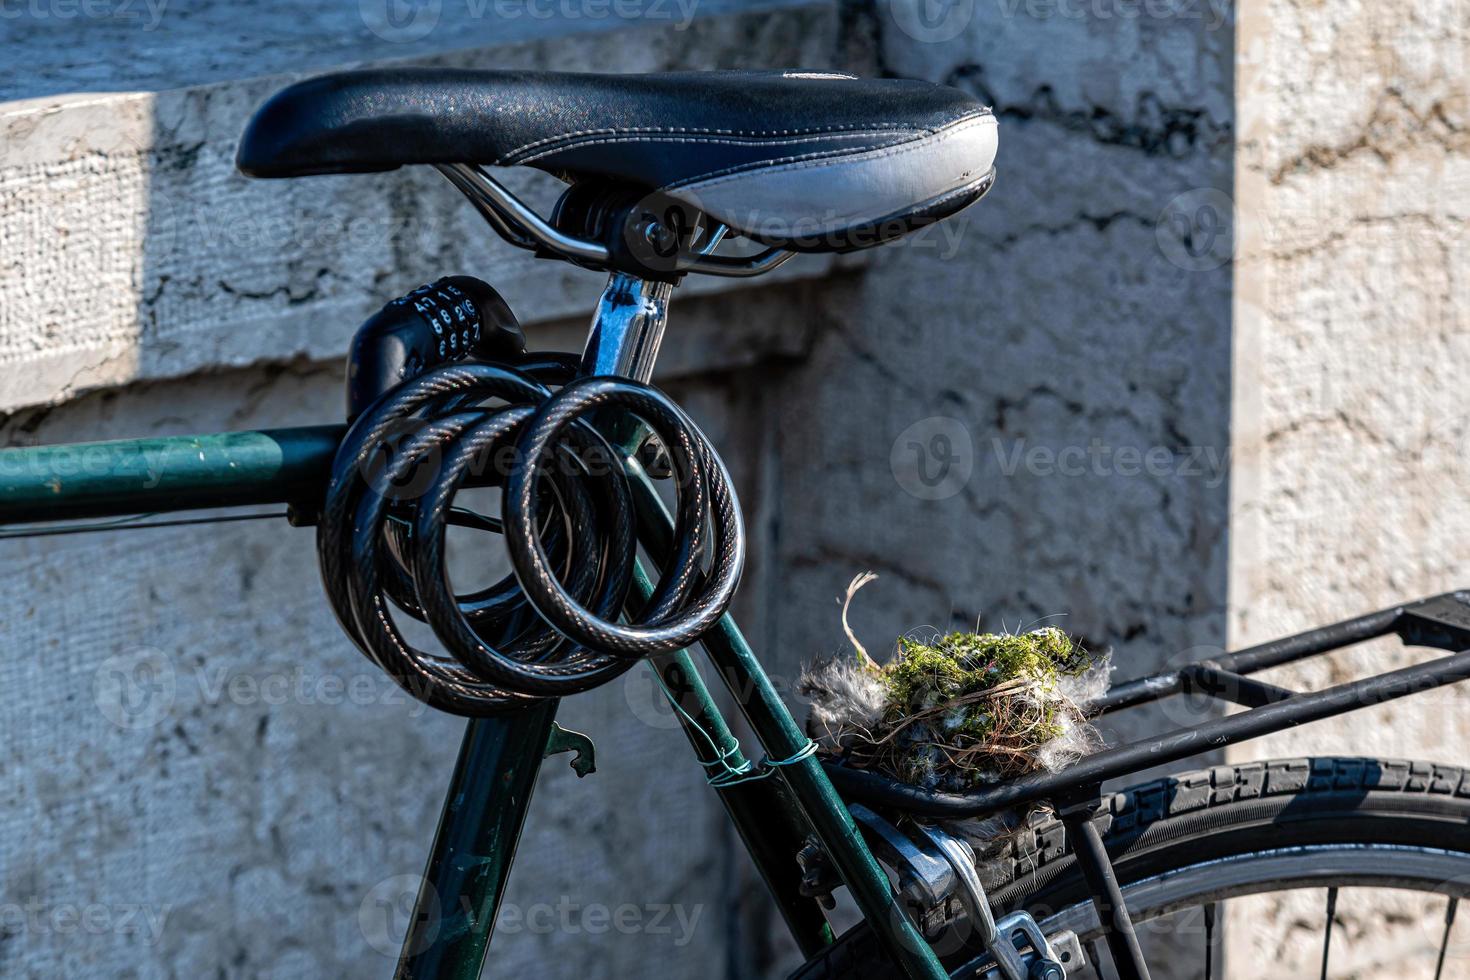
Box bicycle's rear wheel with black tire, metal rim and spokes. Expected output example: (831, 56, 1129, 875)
(792, 758, 1470, 980)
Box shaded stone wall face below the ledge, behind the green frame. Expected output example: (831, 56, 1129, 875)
(0, 289, 811, 979)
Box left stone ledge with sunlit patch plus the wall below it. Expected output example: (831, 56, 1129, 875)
(0, 3, 860, 977)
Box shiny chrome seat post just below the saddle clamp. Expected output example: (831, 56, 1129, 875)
(582, 272, 673, 382)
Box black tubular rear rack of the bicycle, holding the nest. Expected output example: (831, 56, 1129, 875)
(825, 591, 1470, 980)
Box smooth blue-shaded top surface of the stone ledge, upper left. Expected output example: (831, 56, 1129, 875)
(0, 0, 793, 101)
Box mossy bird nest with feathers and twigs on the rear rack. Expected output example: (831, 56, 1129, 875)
(800, 576, 1110, 792)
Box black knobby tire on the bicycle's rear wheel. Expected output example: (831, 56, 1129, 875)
(791, 757, 1470, 980)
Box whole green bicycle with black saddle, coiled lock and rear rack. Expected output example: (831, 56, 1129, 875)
(0, 68, 1470, 980)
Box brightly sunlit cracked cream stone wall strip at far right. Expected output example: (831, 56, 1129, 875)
(1230, 0, 1470, 977)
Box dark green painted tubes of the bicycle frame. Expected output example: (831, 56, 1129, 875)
(0, 387, 947, 980)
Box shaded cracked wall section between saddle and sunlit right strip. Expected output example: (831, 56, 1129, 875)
(761, 3, 1233, 976)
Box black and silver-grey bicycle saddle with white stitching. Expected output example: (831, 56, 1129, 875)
(237, 68, 997, 251)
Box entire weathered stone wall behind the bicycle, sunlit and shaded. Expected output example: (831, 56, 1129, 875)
(0, 0, 1470, 977)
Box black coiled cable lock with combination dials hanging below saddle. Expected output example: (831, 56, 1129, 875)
(318, 276, 745, 717)
